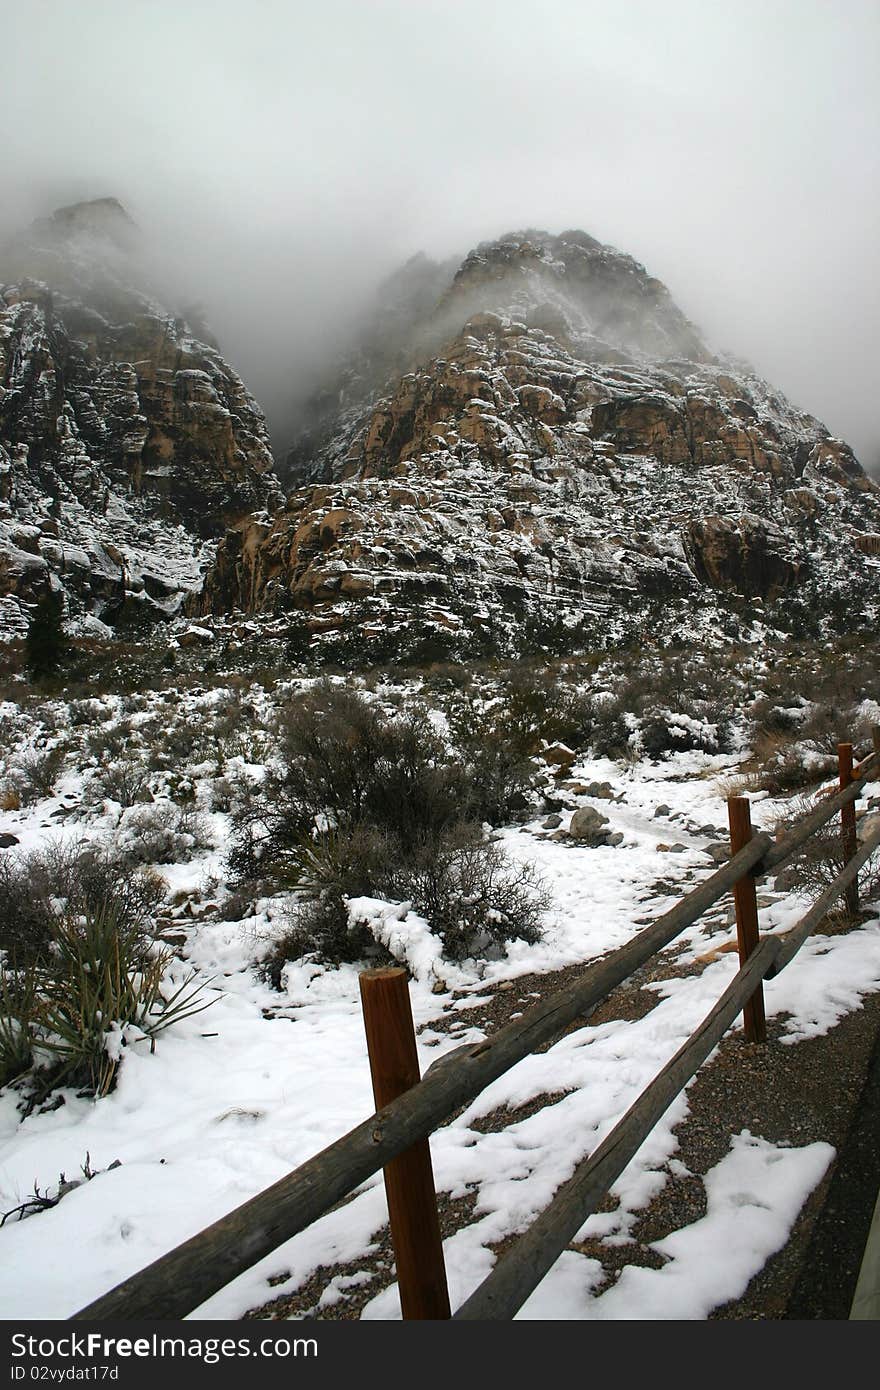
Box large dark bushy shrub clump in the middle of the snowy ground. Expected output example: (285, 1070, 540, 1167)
(228, 684, 550, 981)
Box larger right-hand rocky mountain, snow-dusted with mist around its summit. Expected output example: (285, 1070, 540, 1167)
(193, 232, 880, 653)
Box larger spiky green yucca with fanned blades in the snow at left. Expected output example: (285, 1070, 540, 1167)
(36, 906, 214, 1095)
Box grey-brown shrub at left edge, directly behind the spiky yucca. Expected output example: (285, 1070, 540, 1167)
(0, 842, 165, 967)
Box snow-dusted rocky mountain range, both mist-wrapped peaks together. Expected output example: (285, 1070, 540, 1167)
(0, 215, 880, 659)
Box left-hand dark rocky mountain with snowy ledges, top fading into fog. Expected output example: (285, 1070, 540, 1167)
(0, 199, 278, 634)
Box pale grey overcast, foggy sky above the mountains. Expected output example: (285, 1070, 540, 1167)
(0, 0, 880, 466)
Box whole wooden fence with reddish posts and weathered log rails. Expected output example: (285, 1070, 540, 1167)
(74, 728, 880, 1322)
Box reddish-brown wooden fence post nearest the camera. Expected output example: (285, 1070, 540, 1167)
(360, 969, 450, 1319)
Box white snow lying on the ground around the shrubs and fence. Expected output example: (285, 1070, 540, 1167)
(0, 733, 880, 1319)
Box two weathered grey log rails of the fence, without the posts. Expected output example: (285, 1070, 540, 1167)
(74, 731, 880, 1321)
